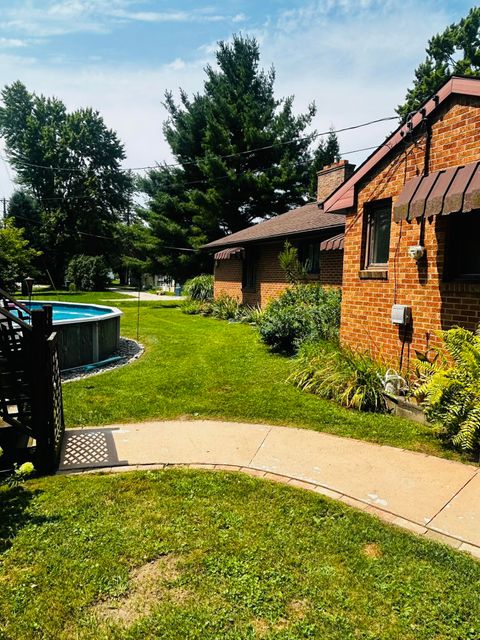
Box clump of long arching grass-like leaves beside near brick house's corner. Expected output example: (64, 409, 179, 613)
(289, 342, 387, 413)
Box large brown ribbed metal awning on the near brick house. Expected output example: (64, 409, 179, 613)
(393, 160, 480, 222)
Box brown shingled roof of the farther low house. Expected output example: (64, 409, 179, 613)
(203, 202, 345, 249)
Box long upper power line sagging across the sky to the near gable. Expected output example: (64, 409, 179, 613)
(1, 116, 397, 173)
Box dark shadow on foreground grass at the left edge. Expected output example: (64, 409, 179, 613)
(0, 486, 52, 554)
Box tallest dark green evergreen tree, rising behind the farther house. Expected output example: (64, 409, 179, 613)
(140, 36, 315, 277)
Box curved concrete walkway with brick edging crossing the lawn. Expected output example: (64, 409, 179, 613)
(60, 420, 480, 557)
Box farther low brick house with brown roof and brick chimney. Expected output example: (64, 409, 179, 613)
(204, 160, 354, 307)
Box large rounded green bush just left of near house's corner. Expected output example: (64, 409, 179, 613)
(258, 284, 341, 355)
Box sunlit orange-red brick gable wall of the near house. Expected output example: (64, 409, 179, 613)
(341, 97, 480, 370)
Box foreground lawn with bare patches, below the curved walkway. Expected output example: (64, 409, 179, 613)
(0, 470, 480, 640)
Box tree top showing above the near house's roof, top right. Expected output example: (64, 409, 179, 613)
(397, 7, 480, 120)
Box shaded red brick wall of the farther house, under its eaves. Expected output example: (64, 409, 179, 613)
(214, 243, 343, 307)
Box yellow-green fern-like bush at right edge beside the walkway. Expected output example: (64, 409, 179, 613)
(414, 327, 480, 451)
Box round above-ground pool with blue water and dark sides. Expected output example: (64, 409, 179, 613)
(22, 300, 122, 370)
